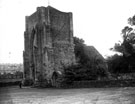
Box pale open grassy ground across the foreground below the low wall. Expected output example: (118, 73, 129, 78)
(0, 86, 135, 104)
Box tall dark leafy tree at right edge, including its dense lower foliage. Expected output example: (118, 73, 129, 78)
(108, 15, 135, 73)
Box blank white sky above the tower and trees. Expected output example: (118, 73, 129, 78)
(0, 0, 135, 63)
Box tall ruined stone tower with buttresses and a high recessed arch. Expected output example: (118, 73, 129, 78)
(23, 6, 75, 86)
